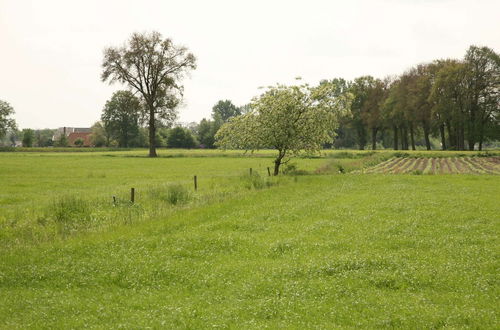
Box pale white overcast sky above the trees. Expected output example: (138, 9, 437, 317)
(0, 0, 500, 128)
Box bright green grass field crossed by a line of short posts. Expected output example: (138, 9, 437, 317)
(0, 150, 500, 329)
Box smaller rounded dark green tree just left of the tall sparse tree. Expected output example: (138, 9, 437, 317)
(101, 91, 141, 148)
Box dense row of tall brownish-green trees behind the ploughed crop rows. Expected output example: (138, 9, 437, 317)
(344, 46, 500, 150)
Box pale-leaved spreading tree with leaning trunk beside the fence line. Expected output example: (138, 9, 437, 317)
(216, 83, 350, 175)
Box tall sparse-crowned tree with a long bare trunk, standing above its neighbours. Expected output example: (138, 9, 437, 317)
(101, 32, 196, 157)
